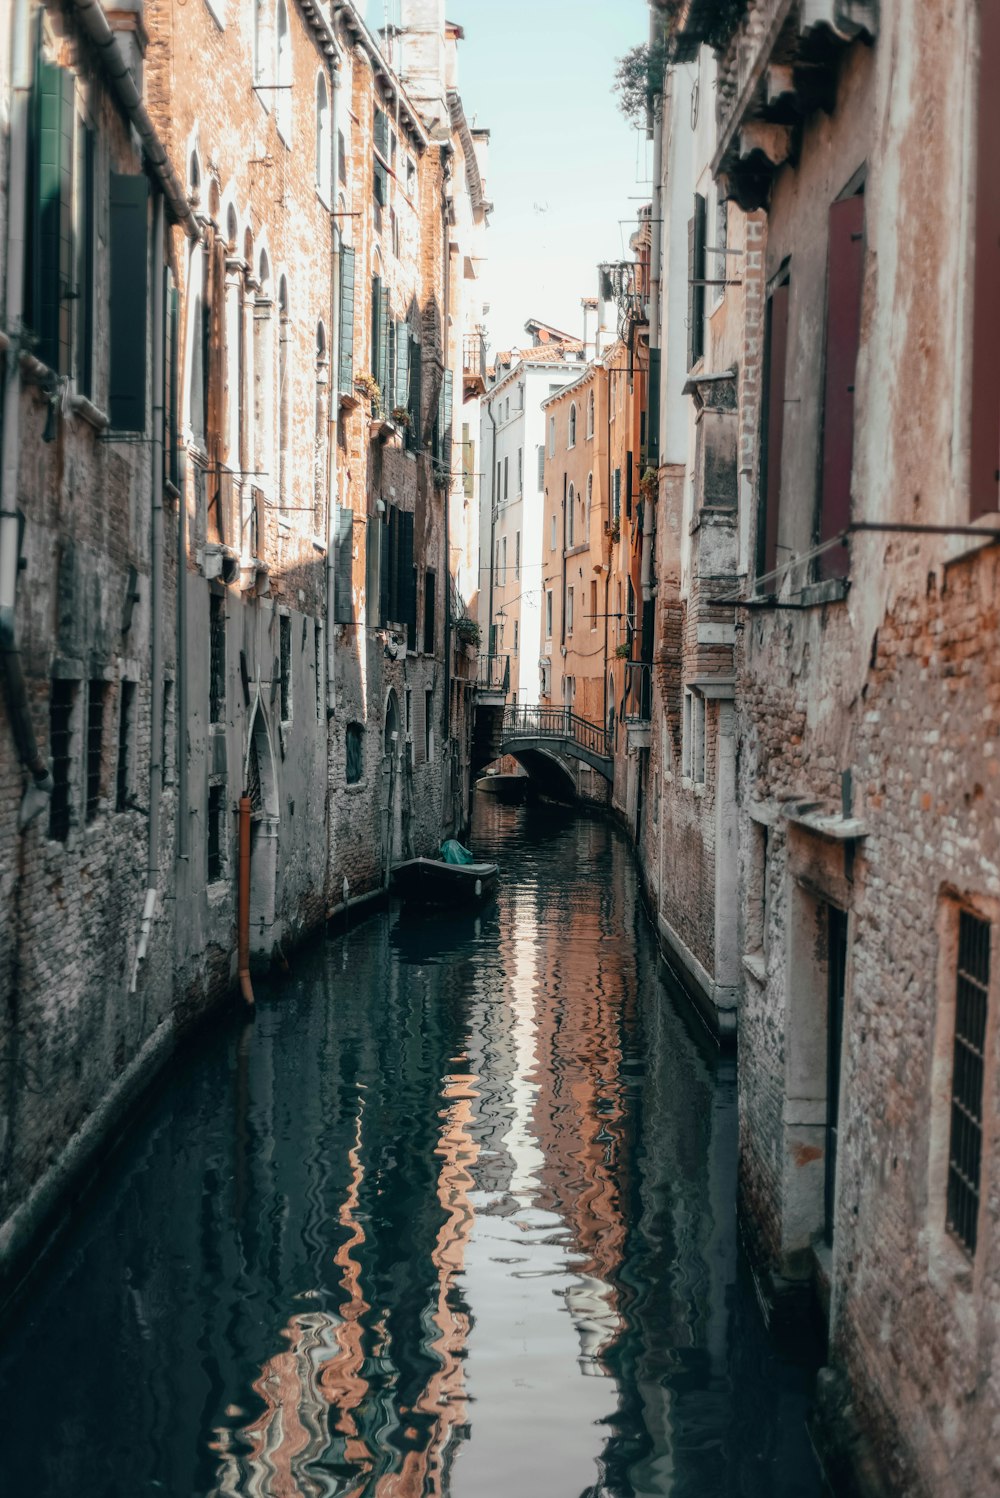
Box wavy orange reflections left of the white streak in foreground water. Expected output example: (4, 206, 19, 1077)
(209, 1018, 478, 1498)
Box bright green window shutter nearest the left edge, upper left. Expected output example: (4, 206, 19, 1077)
(31, 60, 73, 373)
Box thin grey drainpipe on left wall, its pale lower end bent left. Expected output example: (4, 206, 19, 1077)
(129, 192, 163, 993)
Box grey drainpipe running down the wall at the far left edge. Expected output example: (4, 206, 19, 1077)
(0, 0, 52, 831)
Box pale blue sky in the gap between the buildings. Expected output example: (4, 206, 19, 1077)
(368, 0, 651, 352)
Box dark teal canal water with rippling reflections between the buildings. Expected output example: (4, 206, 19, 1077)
(0, 801, 820, 1498)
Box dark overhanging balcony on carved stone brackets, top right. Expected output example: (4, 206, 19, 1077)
(700, 0, 877, 213)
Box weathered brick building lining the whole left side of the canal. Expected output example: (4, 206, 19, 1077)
(0, 0, 490, 1312)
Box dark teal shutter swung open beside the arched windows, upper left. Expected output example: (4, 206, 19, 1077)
(108, 172, 148, 431)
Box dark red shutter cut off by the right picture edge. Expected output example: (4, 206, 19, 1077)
(969, 0, 1000, 520)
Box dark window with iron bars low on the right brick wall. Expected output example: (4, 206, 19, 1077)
(946, 911, 991, 1254)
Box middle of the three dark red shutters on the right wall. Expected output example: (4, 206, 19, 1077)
(819, 196, 865, 577)
